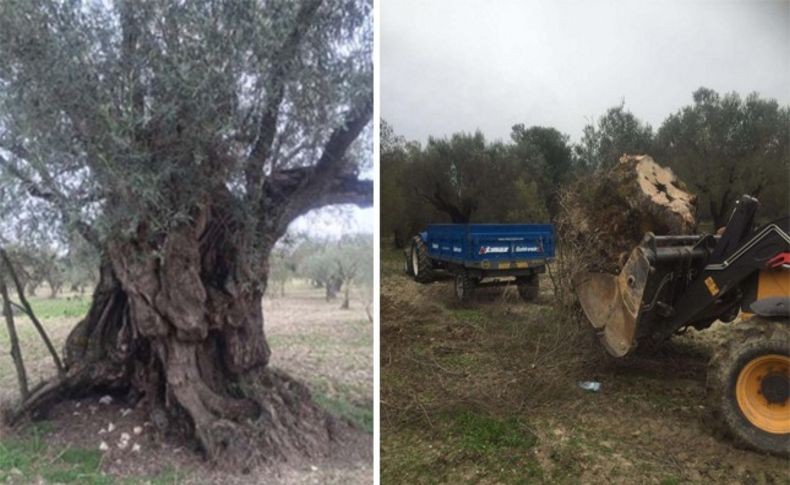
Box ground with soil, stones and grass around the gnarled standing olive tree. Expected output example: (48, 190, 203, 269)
(0, 285, 373, 484)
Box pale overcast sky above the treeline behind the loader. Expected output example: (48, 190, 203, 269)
(380, 0, 790, 142)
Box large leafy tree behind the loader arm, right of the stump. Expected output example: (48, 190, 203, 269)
(656, 88, 790, 227)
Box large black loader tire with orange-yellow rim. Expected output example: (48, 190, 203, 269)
(707, 317, 790, 456)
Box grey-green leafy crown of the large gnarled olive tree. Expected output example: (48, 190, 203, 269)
(0, 0, 372, 248)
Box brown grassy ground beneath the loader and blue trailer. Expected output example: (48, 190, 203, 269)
(381, 250, 790, 485)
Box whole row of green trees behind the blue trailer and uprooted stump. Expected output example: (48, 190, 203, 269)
(381, 88, 790, 240)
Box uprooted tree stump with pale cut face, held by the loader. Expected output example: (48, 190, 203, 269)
(556, 155, 697, 304)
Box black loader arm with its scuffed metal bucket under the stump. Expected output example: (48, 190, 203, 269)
(574, 196, 790, 357)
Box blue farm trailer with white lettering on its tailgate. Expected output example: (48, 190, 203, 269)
(405, 224, 554, 301)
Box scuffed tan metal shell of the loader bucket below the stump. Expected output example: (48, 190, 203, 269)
(573, 248, 650, 357)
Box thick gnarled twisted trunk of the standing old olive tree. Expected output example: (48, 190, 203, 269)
(10, 210, 348, 466)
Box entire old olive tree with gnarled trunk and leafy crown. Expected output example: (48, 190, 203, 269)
(0, 0, 372, 460)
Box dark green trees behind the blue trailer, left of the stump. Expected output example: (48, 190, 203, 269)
(381, 120, 560, 247)
